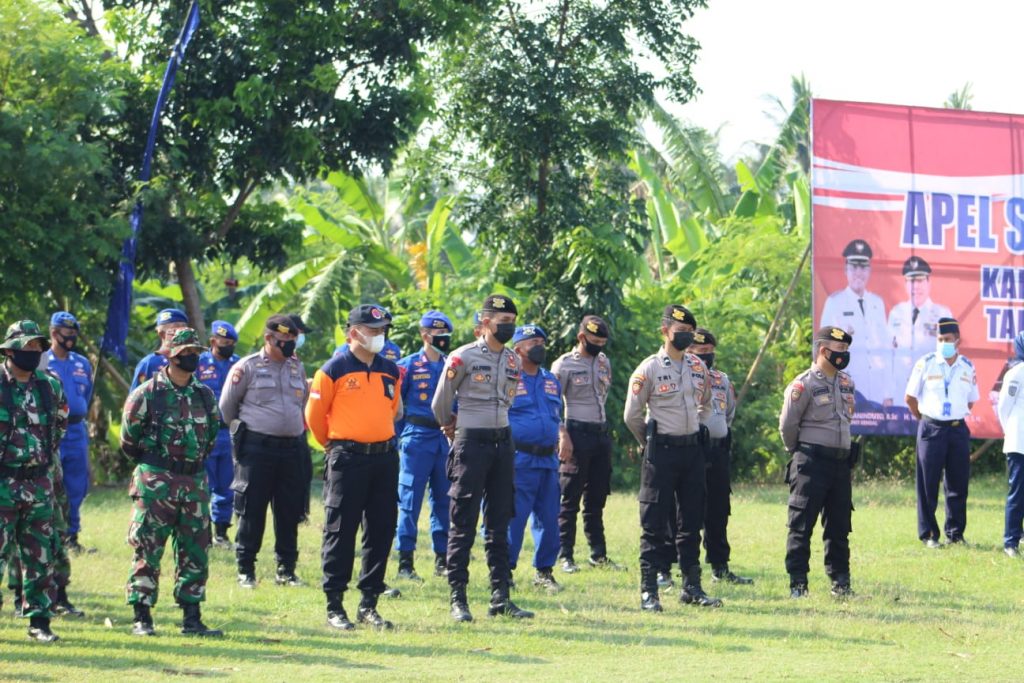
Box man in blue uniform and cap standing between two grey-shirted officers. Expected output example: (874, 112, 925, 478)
(508, 325, 564, 592)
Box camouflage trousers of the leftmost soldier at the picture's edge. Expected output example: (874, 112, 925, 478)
(0, 474, 57, 617)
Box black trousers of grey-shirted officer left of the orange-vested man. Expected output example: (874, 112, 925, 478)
(231, 432, 309, 573)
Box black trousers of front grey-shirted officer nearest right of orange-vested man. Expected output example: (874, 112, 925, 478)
(447, 435, 515, 589)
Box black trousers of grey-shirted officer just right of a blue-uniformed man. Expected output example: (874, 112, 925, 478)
(558, 426, 611, 559)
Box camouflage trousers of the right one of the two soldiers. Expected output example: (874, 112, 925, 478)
(127, 465, 211, 606)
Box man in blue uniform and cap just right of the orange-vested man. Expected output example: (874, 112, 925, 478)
(393, 310, 454, 581)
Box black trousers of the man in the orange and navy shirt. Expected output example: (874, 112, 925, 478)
(321, 446, 398, 596)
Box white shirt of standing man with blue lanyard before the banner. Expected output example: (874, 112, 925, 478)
(906, 351, 978, 420)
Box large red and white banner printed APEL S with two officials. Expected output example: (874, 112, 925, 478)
(811, 99, 1024, 438)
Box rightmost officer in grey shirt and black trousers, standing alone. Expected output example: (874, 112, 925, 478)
(778, 327, 859, 598)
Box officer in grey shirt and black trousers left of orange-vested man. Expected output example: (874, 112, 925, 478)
(220, 315, 309, 588)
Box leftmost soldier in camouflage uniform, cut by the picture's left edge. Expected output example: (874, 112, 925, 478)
(0, 321, 68, 642)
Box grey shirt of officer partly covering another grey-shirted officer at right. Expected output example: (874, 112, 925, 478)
(623, 347, 711, 445)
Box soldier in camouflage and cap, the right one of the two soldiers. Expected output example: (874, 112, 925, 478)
(121, 328, 223, 636)
